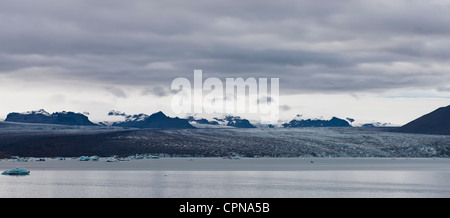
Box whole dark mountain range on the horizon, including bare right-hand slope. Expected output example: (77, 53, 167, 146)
(5, 106, 450, 135)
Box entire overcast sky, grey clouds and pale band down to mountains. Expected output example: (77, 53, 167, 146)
(0, 0, 450, 124)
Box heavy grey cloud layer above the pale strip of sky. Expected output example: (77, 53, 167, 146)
(0, 0, 450, 94)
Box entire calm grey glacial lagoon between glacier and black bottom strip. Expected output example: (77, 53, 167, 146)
(0, 158, 450, 198)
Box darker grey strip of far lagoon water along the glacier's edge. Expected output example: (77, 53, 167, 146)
(0, 157, 450, 171)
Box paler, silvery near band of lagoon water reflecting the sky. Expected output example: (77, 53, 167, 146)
(0, 171, 450, 198)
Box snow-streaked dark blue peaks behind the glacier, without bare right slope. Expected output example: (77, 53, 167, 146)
(5, 109, 394, 129)
